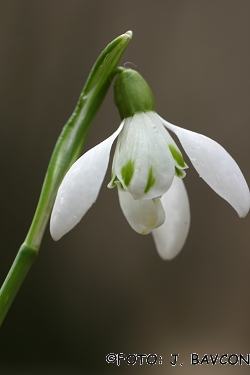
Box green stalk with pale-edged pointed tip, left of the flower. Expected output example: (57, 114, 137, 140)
(0, 31, 132, 326)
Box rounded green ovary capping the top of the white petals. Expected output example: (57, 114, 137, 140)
(114, 69, 155, 120)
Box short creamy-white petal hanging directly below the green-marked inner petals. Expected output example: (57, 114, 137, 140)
(117, 184, 165, 234)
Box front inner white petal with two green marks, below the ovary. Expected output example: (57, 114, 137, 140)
(114, 113, 175, 199)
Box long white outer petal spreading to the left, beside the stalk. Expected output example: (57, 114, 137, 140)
(50, 122, 123, 241)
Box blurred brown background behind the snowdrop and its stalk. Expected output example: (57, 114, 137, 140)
(0, 0, 250, 375)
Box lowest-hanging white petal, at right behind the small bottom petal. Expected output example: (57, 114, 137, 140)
(152, 177, 190, 260)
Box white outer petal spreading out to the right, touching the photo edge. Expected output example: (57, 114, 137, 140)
(161, 119, 250, 217)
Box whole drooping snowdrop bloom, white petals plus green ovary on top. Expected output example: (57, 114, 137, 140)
(50, 69, 250, 259)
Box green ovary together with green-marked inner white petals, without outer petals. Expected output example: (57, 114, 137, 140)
(109, 69, 187, 199)
